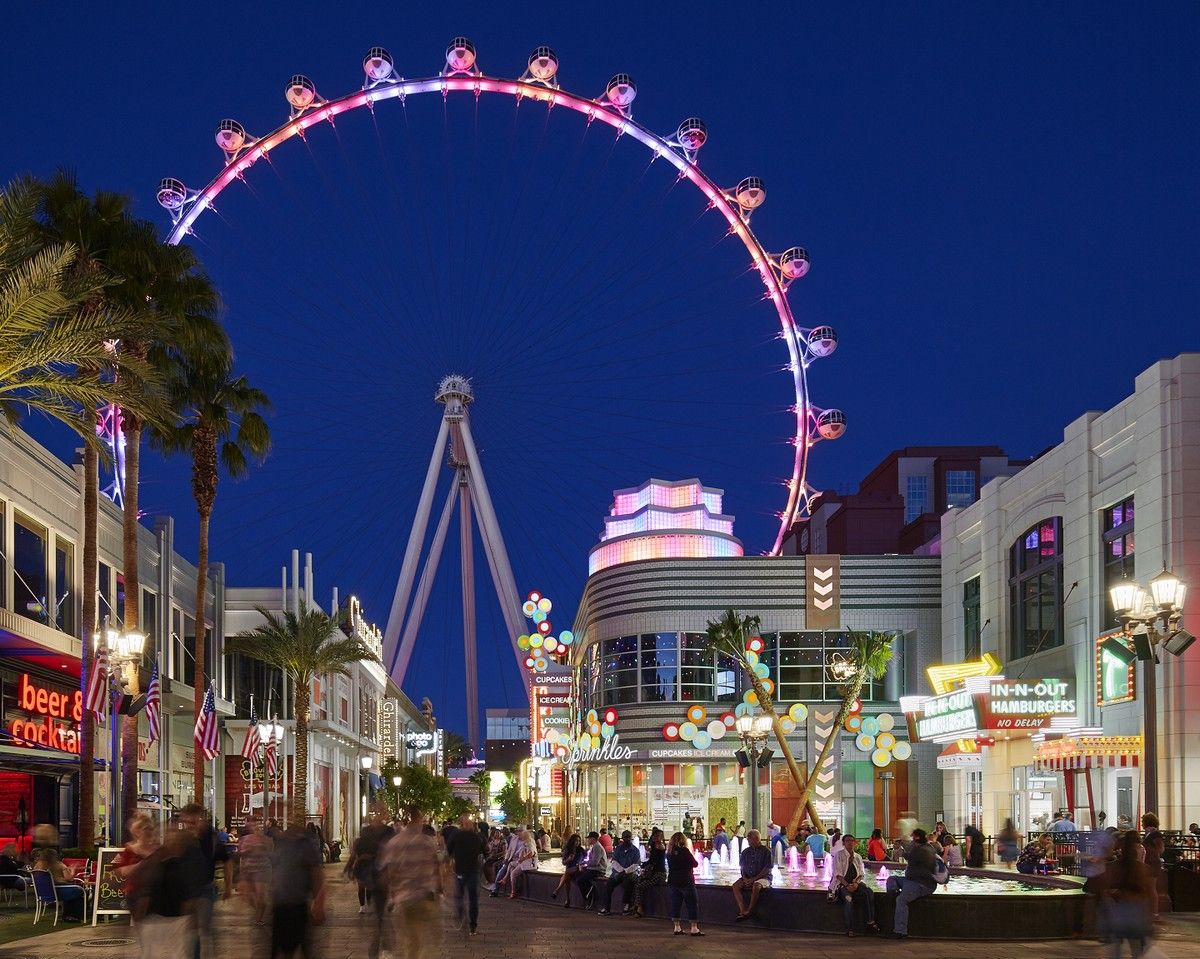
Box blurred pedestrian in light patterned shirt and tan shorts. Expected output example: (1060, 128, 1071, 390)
(383, 805, 443, 959)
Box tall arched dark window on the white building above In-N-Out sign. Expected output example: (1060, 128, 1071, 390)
(1008, 516, 1063, 659)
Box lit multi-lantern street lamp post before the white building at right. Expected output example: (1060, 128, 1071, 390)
(1103, 568, 1195, 814)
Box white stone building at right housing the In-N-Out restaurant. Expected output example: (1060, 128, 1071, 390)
(940, 353, 1200, 833)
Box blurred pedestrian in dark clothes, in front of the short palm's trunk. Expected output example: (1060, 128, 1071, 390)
(270, 820, 325, 959)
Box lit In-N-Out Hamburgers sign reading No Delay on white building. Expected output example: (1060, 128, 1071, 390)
(906, 676, 1076, 741)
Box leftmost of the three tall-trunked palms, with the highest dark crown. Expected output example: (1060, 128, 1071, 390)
(32, 170, 136, 849)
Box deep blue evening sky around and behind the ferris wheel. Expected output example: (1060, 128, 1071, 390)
(0, 2, 1200, 744)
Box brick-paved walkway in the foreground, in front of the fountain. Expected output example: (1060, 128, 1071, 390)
(0, 865, 1200, 959)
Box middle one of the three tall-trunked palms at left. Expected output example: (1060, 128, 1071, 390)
(108, 220, 230, 825)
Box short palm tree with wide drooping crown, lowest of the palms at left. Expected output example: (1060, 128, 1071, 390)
(226, 600, 378, 828)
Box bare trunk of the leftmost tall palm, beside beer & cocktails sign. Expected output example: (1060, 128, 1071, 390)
(78, 434, 100, 853)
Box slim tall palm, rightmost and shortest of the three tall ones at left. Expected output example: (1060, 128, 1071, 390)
(150, 356, 271, 802)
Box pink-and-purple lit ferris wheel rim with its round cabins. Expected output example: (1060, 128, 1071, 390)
(157, 43, 846, 555)
